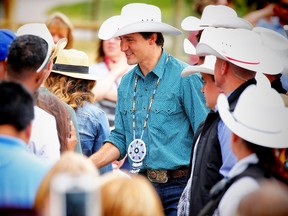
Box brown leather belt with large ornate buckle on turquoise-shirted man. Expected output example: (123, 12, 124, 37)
(140, 168, 188, 183)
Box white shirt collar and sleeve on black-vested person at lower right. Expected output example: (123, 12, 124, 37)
(214, 154, 259, 216)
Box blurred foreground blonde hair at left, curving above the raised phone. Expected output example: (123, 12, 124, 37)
(34, 151, 99, 213)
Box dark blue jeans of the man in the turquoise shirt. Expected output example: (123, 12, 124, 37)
(152, 177, 187, 216)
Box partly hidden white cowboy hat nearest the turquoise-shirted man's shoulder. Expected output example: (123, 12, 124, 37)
(181, 55, 216, 77)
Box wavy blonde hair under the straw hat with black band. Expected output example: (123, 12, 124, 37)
(45, 72, 96, 109)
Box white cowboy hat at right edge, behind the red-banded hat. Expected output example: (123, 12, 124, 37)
(252, 27, 288, 74)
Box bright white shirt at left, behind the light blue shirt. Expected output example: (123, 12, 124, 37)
(28, 106, 60, 163)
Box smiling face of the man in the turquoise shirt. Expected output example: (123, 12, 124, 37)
(120, 33, 152, 65)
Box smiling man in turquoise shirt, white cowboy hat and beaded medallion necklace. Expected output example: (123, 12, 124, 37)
(91, 3, 207, 215)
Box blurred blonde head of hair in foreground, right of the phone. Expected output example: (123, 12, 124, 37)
(100, 173, 164, 216)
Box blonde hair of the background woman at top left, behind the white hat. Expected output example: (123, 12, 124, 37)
(46, 12, 74, 49)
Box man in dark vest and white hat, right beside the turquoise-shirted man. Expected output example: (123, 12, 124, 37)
(177, 55, 223, 216)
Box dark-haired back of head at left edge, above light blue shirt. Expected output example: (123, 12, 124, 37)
(0, 81, 34, 132)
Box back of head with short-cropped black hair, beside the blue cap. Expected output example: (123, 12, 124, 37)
(7, 35, 49, 91)
